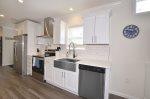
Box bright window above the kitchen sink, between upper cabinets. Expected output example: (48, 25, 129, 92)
(67, 26, 83, 45)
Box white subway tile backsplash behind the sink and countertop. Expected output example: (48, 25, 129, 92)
(60, 45, 110, 61)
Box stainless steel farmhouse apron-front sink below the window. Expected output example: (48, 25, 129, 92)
(54, 58, 79, 72)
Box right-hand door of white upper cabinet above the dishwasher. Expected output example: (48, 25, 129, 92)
(94, 14, 109, 44)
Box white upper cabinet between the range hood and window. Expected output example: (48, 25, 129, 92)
(53, 19, 67, 44)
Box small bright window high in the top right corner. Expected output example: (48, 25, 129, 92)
(136, 0, 150, 13)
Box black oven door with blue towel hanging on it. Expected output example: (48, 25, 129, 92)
(32, 57, 44, 75)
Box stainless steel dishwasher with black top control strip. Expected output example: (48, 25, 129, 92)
(79, 64, 105, 99)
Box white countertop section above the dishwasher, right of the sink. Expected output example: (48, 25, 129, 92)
(77, 60, 111, 68)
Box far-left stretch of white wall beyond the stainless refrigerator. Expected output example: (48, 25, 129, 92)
(2, 24, 16, 66)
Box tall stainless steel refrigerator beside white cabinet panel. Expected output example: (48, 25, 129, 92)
(14, 34, 27, 75)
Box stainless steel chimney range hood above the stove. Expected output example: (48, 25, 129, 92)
(38, 17, 54, 37)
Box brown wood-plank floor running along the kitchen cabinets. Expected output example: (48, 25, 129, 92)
(0, 66, 124, 99)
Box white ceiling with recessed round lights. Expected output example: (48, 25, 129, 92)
(0, 0, 118, 21)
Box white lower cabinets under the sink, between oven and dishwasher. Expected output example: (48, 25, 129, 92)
(44, 58, 78, 95)
